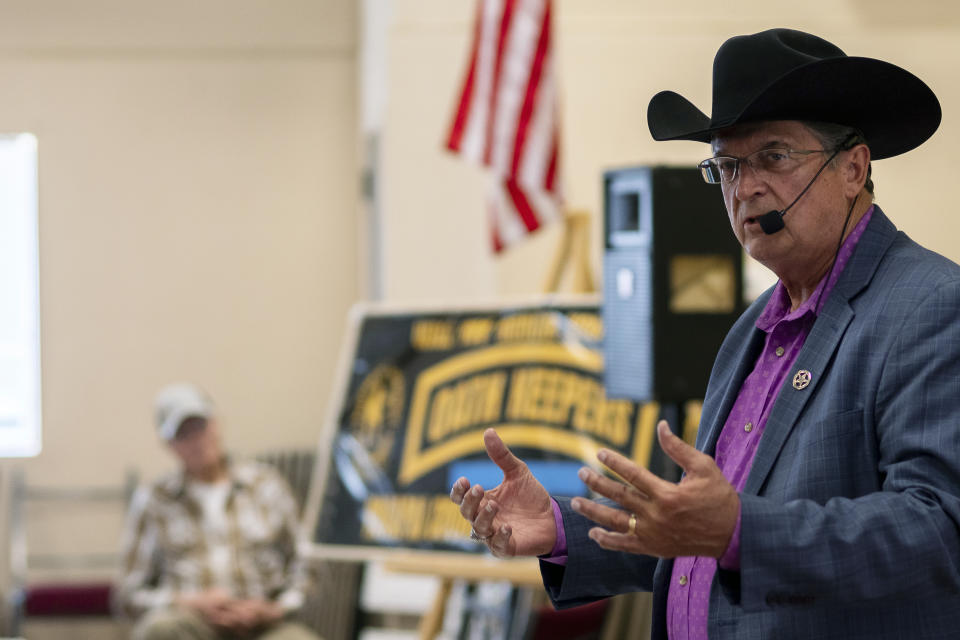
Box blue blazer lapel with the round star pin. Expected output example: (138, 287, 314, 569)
(744, 207, 897, 495)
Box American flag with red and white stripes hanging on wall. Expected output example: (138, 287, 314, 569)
(446, 0, 561, 253)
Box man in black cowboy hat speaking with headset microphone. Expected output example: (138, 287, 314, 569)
(451, 29, 960, 640)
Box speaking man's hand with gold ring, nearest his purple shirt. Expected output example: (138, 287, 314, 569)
(571, 420, 740, 558)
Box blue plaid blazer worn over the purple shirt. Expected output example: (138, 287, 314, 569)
(541, 208, 960, 640)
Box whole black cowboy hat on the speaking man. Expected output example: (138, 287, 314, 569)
(647, 29, 940, 160)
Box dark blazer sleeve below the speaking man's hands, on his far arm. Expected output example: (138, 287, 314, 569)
(540, 498, 658, 609)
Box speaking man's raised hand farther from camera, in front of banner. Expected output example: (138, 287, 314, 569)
(450, 429, 557, 558)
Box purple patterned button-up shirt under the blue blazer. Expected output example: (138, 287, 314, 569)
(667, 207, 873, 640)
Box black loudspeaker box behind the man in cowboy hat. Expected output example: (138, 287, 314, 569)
(603, 167, 744, 403)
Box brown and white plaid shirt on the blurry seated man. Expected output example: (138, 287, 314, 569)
(116, 462, 309, 615)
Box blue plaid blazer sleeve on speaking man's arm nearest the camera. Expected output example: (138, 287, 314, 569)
(732, 279, 960, 611)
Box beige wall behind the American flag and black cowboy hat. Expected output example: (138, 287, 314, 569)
(384, 0, 960, 299)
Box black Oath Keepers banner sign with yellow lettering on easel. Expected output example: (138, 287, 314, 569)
(311, 301, 699, 551)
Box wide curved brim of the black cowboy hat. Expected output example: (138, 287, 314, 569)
(647, 56, 941, 160)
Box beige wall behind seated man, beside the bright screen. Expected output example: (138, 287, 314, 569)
(0, 0, 359, 496)
